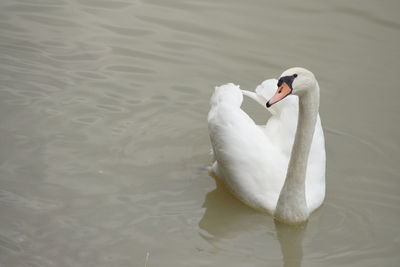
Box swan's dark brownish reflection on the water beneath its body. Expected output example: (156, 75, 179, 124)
(199, 181, 307, 267)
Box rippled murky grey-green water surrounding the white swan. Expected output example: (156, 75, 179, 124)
(0, 0, 400, 267)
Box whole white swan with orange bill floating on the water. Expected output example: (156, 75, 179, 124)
(208, 67, 325, 224)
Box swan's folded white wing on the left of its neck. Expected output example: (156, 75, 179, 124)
(208, 84, 287, 213)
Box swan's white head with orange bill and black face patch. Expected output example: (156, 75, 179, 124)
(267, 67, 317, 108)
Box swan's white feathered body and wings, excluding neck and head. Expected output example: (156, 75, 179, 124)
(208, 79, 325, 217)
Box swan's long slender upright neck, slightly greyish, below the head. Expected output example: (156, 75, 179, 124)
(274, 84, 319, 224)
